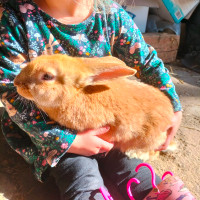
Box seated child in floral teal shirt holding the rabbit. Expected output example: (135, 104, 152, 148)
(0, 0, 182, 200)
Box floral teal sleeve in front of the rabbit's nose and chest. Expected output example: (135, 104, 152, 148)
(0, 11, 76, 169)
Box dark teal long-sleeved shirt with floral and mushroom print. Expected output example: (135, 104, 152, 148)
(0, 0, 181, 181)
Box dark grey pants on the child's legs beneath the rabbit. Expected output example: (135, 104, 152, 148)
(51, 149, 161, 200)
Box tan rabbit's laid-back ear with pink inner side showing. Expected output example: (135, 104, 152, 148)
(78, 56, 137, 86)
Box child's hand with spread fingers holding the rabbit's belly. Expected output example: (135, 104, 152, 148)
(68, 126, 113, 156)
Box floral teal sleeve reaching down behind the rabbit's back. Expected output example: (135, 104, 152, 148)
(113, 5, 181, 111)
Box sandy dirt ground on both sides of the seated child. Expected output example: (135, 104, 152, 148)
(0, 62, 200, 200)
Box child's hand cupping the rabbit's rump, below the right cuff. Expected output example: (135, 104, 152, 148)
(157, 111, 182, 151)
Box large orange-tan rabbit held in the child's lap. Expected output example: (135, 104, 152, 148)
(14, 54, 174, 160)
